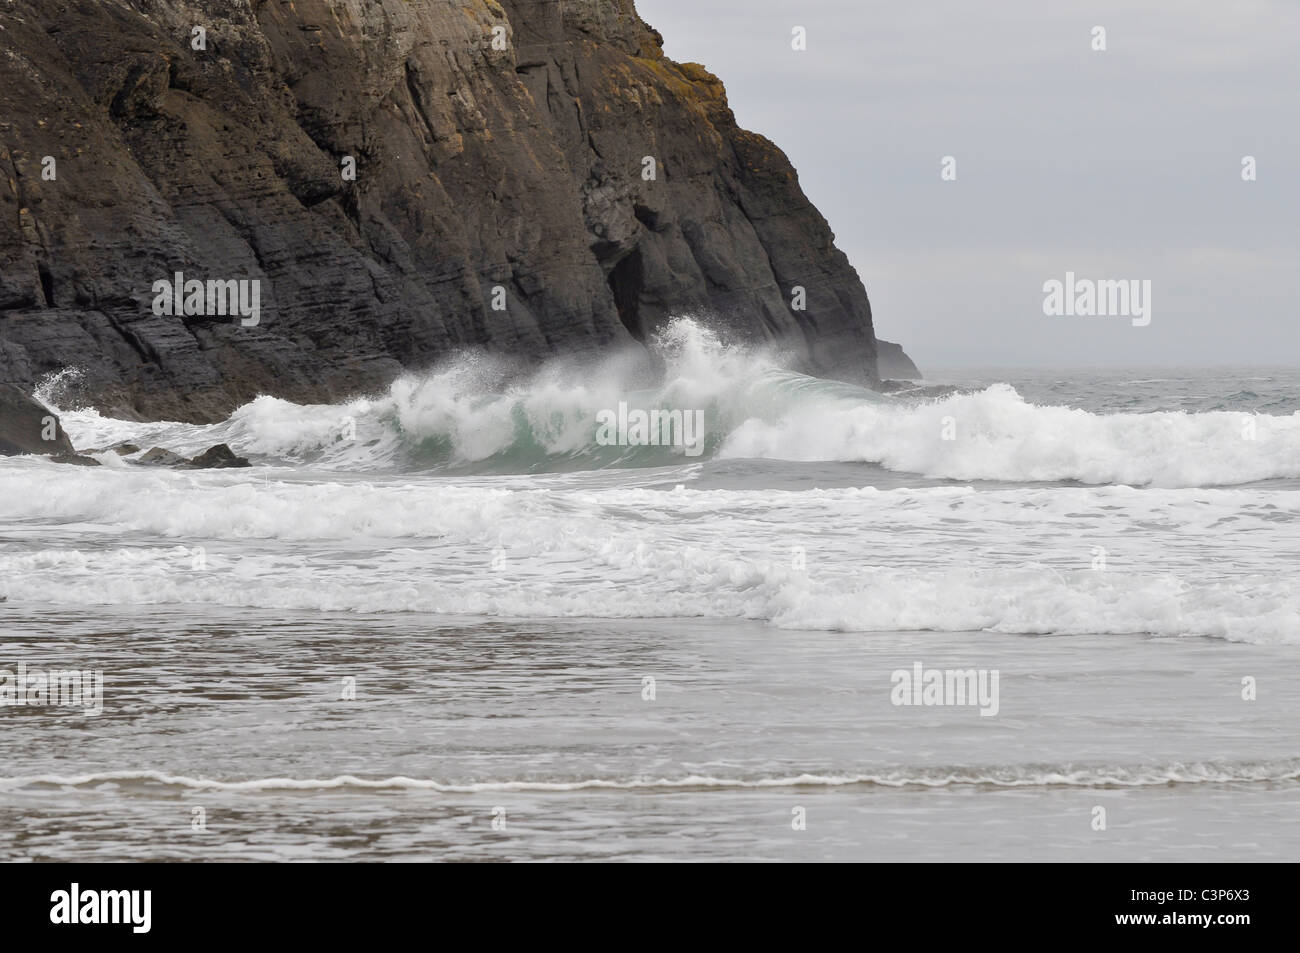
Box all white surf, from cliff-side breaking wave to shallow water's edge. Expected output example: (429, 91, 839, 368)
(12, 321, 1300, 642)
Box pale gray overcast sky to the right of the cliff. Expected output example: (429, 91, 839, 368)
(637, 0, 1300, 371)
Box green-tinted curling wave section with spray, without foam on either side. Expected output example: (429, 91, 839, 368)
(371, 320, 881, 475)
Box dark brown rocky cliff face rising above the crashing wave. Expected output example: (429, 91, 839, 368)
(0, 0, 876, 420)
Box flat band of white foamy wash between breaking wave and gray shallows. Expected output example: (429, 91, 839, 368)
(0, 462, 1300, 644)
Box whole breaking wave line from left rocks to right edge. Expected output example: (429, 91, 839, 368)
(46, 319, 1300, 488)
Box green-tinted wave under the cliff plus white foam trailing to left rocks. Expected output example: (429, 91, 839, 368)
(35, 319, 883, 475)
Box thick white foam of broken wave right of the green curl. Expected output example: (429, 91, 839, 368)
(722, 384, 1300, 486)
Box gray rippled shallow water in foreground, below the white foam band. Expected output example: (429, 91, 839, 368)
(0, 607, 1300, 861)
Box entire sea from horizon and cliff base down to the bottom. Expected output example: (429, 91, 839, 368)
(0, 320, 1300, 862)
